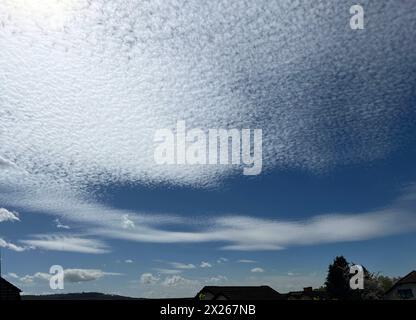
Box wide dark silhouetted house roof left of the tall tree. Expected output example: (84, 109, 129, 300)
(196, 286, 283, 300)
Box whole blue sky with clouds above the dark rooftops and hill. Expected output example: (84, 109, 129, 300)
(0, 0, 416, 298)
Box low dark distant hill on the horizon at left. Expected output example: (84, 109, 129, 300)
(22, 292, 144, 300)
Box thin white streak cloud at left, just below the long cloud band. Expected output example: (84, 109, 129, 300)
(21, 234, 109, 254)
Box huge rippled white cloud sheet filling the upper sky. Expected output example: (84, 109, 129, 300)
(0, 0, 416, 236)
